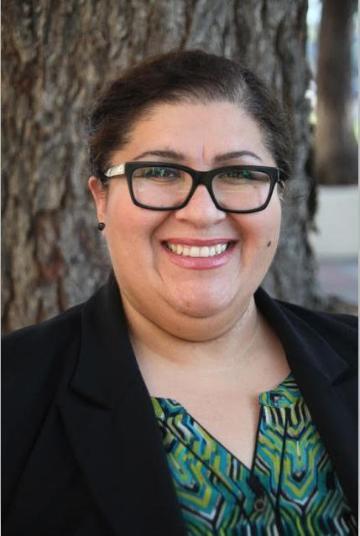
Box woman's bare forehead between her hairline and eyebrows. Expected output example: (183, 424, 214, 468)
(114, 101, 271, 160)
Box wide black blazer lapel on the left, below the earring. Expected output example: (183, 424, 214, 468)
(58, 278, 185, 536)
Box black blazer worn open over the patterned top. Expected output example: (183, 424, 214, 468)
(3, 277, 357, 536)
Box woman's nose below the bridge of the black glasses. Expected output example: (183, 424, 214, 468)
(175, 184, 226, 227)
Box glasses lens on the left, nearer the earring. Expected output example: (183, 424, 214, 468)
(132, 166, 192, 208)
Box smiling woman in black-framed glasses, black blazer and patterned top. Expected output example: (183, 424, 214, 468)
(4, 51, 356, 536)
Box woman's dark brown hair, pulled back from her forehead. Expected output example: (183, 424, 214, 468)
(89, 50, 292, 179)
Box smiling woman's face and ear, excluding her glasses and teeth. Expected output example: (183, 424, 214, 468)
(89, 102, 281, 336)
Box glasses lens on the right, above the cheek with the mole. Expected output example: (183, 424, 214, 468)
(212, 168, 271, 210)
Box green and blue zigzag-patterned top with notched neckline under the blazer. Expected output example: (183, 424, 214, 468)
(152, 375, 357, 536)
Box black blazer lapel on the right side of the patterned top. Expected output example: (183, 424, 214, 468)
(255, 289, 357, 513)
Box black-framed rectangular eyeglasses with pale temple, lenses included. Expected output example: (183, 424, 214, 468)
(104, 162, 285, 213)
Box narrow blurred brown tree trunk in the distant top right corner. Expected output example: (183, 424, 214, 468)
(315, 0, 358, 184)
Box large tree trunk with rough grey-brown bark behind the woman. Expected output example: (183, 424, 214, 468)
(2, 0, 316, 330)
